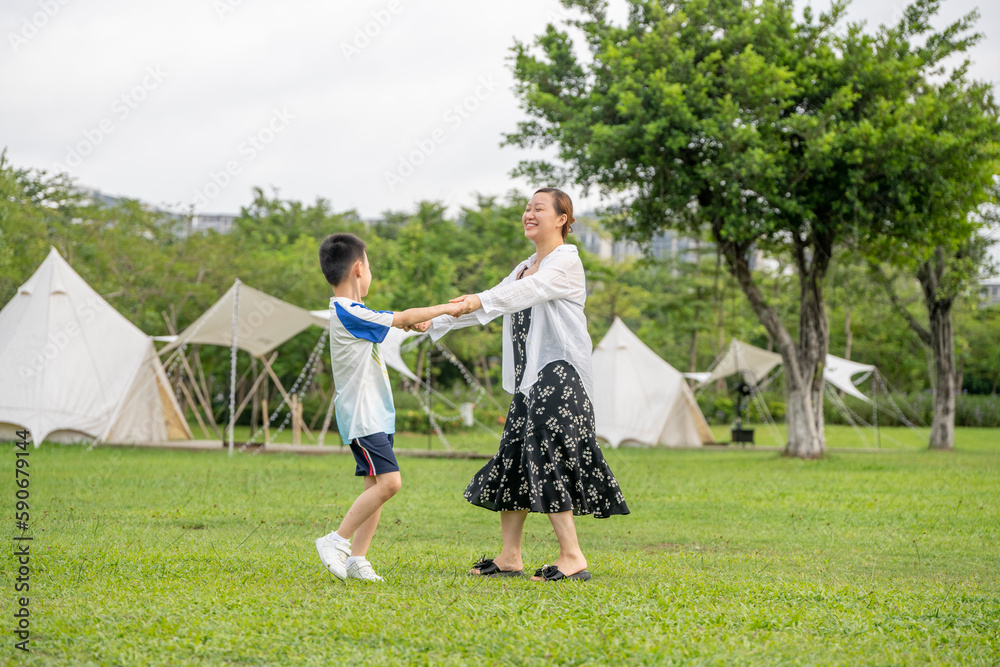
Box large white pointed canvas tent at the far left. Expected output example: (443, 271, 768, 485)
(0, 248, 191, 447)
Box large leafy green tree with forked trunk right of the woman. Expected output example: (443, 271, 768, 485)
(507, 0, 995, 457)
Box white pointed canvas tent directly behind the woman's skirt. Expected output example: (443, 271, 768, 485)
(593, 317, 714, 447)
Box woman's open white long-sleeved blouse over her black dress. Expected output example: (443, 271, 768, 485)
(428, 243, 594, 397)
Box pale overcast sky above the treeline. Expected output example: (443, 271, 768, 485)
(0, 0, 1000, 234)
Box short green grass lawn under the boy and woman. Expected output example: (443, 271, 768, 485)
(7, 429, 1000, 665)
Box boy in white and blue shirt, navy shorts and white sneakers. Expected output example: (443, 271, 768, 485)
(316, 234, 455, 581)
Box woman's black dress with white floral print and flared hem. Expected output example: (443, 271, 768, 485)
(465, 308, 629, 518)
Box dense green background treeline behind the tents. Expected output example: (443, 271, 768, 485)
(0, 160, 1000, 427)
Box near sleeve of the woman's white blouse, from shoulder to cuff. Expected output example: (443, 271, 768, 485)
(479, 252, 586, 318)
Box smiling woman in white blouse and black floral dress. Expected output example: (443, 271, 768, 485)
(430, 188, 629, 581)
